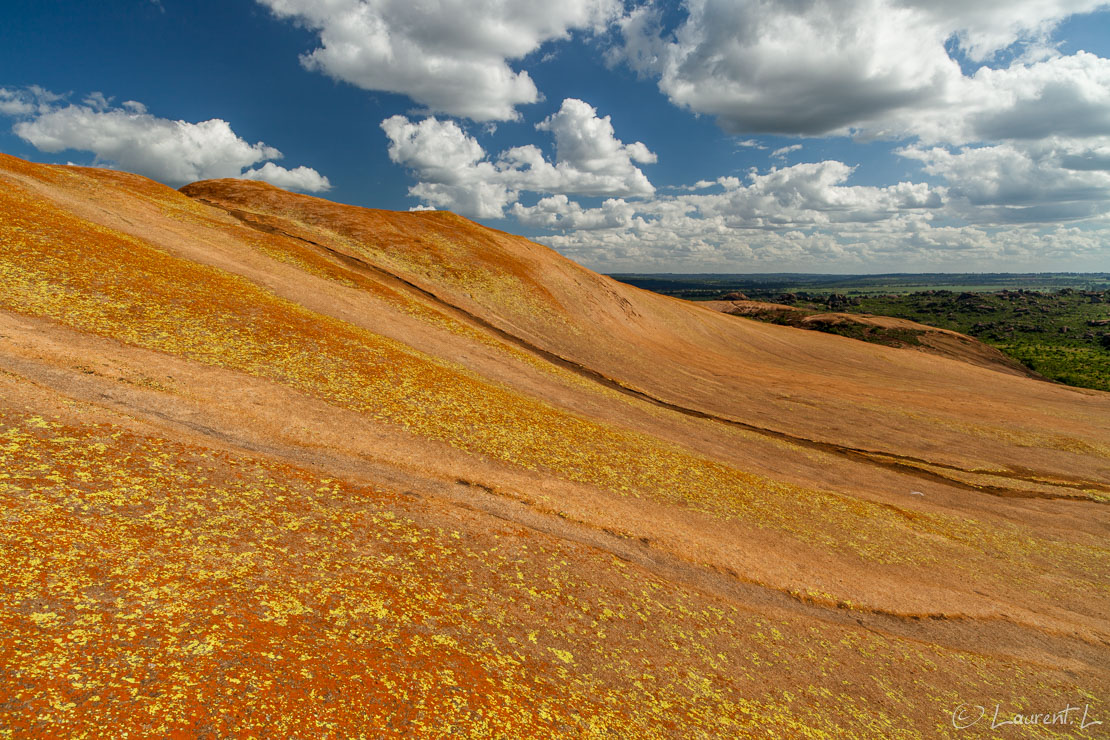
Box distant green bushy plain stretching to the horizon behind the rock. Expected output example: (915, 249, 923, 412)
(614, 273, 1110, 391)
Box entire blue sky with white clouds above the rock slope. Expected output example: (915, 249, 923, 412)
(0, 0, 1110, 273)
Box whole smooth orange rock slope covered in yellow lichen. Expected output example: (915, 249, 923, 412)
(0, 155, 1110, 738)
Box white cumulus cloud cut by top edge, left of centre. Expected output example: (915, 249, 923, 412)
(259, 0, 622, 121)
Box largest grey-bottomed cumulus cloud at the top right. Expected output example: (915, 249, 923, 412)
(614, 0, 1108, 135)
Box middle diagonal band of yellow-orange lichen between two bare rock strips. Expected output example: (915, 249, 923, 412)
(0, 174, 1106, 588)
